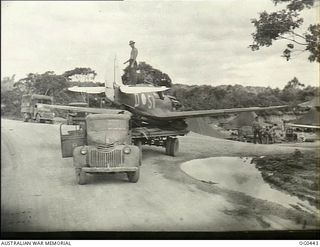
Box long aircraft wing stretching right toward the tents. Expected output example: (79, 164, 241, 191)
(132, 105, 288, 120)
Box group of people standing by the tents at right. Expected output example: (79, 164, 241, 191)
(252, 116, 278, 144)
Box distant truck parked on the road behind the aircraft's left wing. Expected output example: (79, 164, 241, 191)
(21, 94, 55, 123)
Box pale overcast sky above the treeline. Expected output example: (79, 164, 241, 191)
(1, 0, 319, 88)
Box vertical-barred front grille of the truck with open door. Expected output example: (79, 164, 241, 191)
(89, 149, 123, 168)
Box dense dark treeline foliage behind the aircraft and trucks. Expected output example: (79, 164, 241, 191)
(1, 62, 319, 118)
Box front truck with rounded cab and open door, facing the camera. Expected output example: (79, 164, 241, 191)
(60, 110, 142, 185)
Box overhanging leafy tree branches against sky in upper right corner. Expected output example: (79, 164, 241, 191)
(249, 0, 320, 62)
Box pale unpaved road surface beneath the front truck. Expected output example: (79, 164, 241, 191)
(1, 119, 319, 232)
